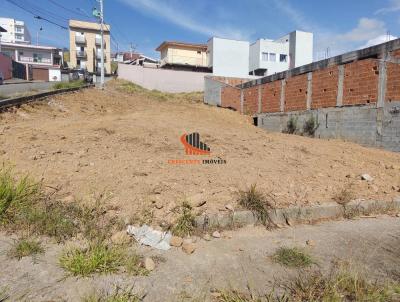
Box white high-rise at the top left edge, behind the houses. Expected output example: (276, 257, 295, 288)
(0, 18, 31, 44)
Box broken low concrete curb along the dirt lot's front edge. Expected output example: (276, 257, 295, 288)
(195, 197, 400, 231)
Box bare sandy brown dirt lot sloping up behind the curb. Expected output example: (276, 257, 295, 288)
(0, 82, 400, 221)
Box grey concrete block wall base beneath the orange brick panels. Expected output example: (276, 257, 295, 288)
(258, 101, 400, 152)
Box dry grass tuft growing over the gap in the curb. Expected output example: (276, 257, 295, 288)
(238, 184, 274, 225)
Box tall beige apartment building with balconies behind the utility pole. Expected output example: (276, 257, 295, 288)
(69, 20, 111, 74)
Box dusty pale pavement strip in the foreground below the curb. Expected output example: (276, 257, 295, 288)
(0, 217, 400, 302)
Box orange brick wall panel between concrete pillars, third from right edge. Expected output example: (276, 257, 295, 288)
(311, 66, 339, 109)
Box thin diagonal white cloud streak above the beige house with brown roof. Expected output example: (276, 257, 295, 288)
(119, 0, 249, 39)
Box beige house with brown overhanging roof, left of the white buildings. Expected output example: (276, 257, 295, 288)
(156, 41, 208, 69)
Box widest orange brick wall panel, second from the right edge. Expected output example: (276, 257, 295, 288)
(343, 59, 379, 105)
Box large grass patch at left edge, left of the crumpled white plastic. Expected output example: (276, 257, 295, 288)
(0, 166, 116, 242)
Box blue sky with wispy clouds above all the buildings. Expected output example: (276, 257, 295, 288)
(0, 0, 400, 58)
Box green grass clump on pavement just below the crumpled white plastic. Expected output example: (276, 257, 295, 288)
(59, 242, 148, 277)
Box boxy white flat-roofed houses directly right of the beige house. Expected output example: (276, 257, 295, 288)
(207, 30, 313, 78)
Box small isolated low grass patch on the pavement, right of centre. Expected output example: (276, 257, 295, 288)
(273, 247, 313, 268)
